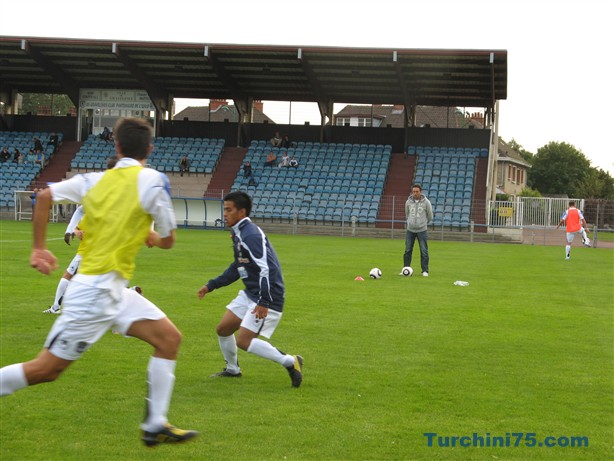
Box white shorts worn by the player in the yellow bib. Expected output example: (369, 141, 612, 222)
(45, 279, 166, 360)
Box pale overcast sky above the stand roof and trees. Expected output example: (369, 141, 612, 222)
(0, 0, 614, 174)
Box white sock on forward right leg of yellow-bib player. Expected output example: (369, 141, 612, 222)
(141, 357, 177, 431)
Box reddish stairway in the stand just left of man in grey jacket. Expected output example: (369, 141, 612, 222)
(377, 153, 416, 228)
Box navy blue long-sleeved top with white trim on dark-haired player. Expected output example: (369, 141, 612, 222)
(207, 218, 285, 312)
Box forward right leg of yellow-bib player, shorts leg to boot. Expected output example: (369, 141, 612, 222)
(114, 289, 198, 446)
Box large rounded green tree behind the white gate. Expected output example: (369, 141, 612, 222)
(528, 142, 591, 197)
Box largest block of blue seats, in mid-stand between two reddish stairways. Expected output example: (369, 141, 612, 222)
(233, 141, 392, 223)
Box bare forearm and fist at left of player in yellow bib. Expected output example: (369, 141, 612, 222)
(30, 188, 58, 275)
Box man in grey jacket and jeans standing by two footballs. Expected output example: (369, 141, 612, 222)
(403, 184, 433, 277)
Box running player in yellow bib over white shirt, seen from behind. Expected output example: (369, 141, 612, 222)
(0, 119, 198, 446)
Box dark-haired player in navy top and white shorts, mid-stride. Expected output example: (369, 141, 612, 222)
(198, 191, 303, 387)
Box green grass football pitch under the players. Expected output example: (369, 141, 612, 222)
(0, 221, 614, 461)
